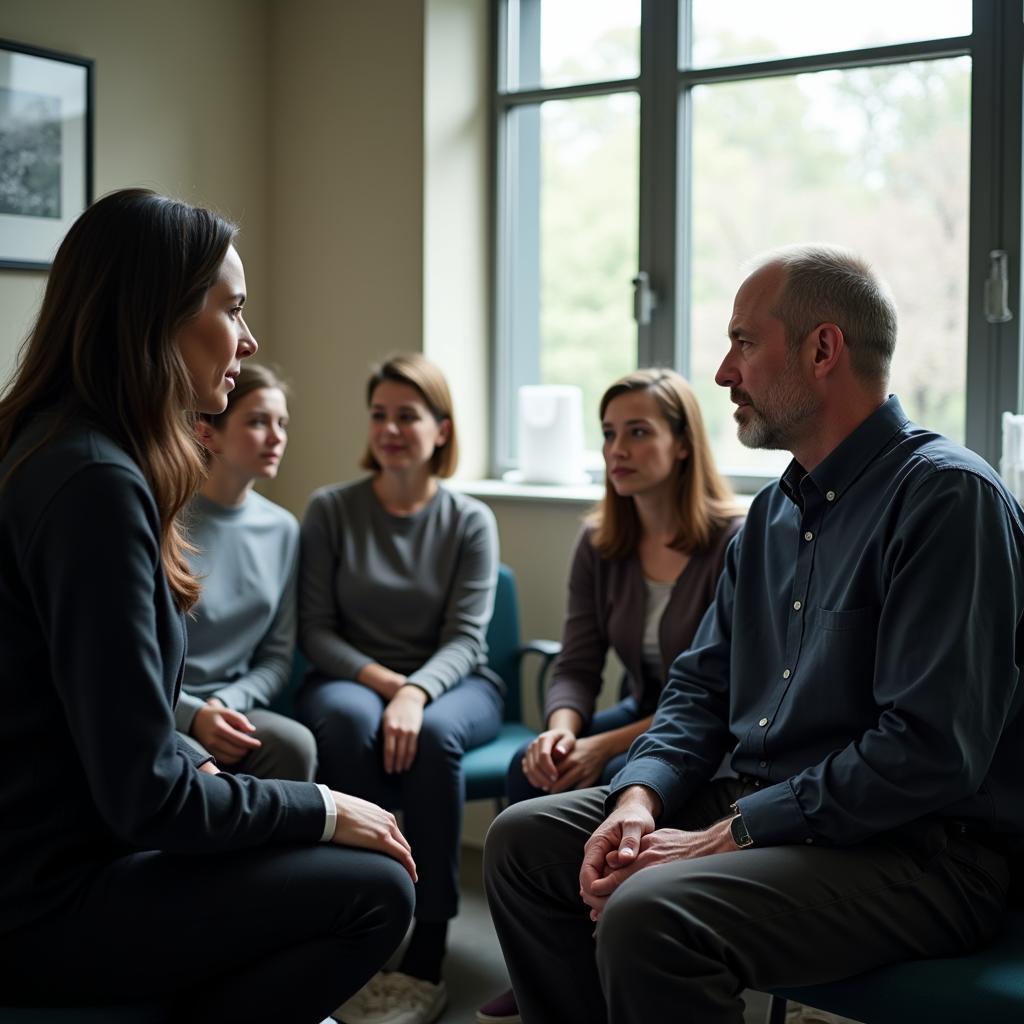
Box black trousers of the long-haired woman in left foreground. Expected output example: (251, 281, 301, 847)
(0, 845, 413, 1024)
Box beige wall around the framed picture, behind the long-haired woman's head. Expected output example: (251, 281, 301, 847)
(0, 0, 269, 379)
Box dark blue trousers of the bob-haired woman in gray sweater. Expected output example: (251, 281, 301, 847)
(296, 676, 502, 924)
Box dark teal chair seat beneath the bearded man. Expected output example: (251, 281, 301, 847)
(768, 909, 1024, 1024)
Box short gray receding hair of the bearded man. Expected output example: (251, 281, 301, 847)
(757, 245, 896, 383)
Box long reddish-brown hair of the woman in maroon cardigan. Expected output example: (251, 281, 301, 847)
(587, 370, 741, 558)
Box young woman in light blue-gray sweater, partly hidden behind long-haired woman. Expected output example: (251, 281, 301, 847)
(180, 362, 316, 782)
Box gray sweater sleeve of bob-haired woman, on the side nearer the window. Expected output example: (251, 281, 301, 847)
(409, 505, 498, 699)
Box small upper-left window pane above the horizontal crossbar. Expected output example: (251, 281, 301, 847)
(506, 0, 640, 90)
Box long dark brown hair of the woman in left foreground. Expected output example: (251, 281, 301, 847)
(0, 188, 237, 610)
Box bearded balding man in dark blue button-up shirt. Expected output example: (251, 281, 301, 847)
(485, 247, 1024, 1024)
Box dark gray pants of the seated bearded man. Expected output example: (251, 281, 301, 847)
(484, 779, 1009, 1024)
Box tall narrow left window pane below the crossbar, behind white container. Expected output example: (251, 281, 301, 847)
(503, 93, 639, 456)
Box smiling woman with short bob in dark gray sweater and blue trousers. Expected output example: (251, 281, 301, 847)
(298, 353, 503, 1024)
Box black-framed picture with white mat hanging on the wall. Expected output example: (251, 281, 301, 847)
(0, 39, 92, 270)
